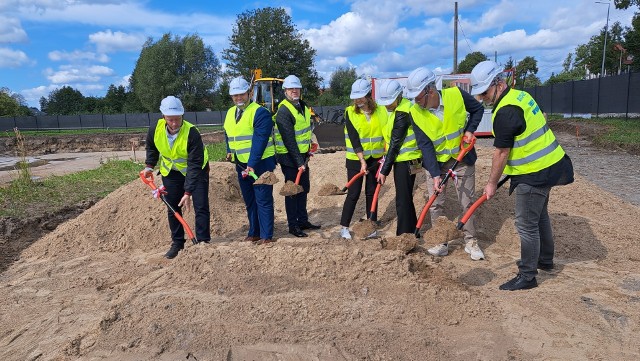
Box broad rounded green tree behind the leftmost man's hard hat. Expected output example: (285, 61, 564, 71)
(129, 33, 220, 112)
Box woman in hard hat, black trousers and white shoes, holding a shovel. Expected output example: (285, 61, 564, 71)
(340, 79, 387, 239)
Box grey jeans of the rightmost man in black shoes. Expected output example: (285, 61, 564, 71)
(515, 183, 554, 280)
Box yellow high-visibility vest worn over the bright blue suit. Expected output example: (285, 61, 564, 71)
(224, 102, 276, 163)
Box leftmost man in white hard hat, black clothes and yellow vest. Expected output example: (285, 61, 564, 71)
(144, 96, 211, 259)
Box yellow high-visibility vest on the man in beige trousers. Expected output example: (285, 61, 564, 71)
(411, 87, 467, 163)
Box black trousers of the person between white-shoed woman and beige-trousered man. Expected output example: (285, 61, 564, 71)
(393, 161, 418, 236)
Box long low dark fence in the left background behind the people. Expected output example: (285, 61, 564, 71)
(0, 106, 344, 131)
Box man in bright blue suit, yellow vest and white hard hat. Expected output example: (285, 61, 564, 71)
(224, 77, 276, 244)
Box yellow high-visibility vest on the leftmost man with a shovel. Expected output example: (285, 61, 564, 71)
(153, 118, 209, 176)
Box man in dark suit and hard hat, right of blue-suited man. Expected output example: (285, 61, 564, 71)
(274, 75, 320, 237)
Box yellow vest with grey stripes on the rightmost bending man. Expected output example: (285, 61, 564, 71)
(491, 89, 565, 175)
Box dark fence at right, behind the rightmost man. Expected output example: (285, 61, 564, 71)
(524, 73, 640, 118)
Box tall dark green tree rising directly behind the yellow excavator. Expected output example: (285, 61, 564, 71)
(222, 7, 322, 101)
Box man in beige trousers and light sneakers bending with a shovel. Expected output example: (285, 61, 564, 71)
(407, 67, 484, 261)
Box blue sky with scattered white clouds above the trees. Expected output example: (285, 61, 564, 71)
(0, 0, 636, 108)
